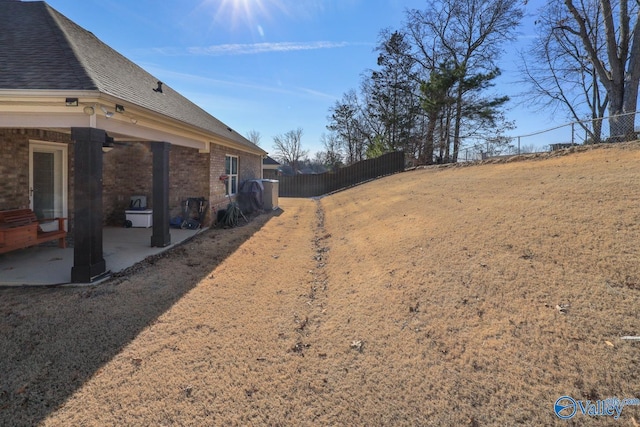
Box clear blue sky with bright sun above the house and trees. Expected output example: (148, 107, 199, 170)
(42, 0, 564, 157)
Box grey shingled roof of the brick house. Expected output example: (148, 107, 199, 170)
(0, 0, 266, 155)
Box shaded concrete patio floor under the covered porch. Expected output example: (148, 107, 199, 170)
(0, 227, 203, 286)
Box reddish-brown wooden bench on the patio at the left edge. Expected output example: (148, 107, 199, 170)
(0, 209, 67, 254)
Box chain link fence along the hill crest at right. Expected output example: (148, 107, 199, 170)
(458, 112, 640, 162)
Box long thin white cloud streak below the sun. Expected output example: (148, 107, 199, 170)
(188, 41, 349, 56)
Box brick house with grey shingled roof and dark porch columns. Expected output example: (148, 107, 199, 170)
(0, 0, 267, 282)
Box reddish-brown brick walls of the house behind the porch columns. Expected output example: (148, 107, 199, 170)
(0, 129, 262, 231)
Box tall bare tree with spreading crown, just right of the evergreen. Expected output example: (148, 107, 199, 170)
(407, 0, 523, 162)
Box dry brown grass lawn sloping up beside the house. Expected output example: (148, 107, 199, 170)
(0, 144, 640, 426)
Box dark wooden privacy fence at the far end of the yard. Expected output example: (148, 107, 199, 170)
(278, 151, 404, 197)
